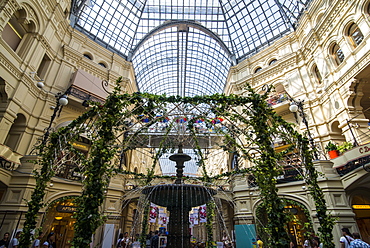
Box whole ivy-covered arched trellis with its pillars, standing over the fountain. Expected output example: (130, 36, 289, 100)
(21, 79, 334, 247)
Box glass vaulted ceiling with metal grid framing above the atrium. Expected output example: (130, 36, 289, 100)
(71, 0, 310, 96)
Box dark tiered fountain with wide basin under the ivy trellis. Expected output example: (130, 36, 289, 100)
(142, 145, 216, 248)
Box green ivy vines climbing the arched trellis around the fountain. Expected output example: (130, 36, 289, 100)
(21, 79, 334, 248)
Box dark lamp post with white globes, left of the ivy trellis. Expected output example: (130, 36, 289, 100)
(36, 81, 70, 152)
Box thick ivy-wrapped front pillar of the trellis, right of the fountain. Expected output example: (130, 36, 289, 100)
(249, 89, 289, 248)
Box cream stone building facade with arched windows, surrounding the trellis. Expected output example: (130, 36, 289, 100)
(0, 0, 370, 247)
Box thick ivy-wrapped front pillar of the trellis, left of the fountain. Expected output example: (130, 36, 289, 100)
(72, 80, 124, 248)
